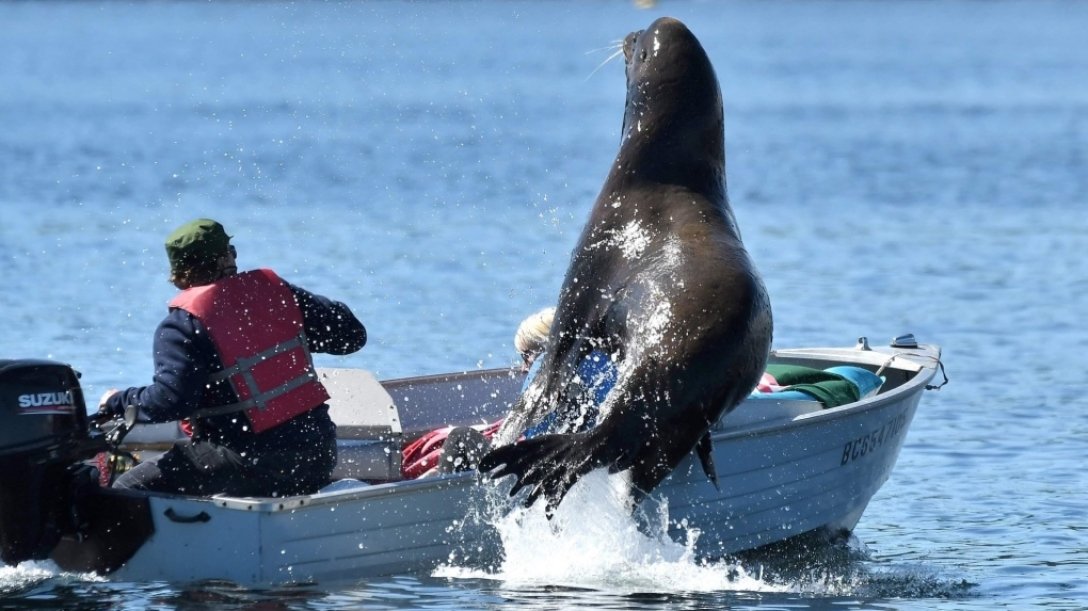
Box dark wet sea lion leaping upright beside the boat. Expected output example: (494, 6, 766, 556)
(480, 17, 772, 511)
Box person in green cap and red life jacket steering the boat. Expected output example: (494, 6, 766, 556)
(99, 219, 367, 497)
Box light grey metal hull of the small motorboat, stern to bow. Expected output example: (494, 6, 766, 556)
(103, 339, 939, 586)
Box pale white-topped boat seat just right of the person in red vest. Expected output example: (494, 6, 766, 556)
(318, 367, 404, 481)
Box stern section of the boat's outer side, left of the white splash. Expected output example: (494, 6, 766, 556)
(111, 477, 487, 585)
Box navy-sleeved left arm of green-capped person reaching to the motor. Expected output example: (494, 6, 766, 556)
(102, 310, 218, 422)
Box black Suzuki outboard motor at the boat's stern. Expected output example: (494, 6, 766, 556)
(0, 359, 106, 564)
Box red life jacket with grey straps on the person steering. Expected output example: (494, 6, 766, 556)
(170, 270, 329, 433)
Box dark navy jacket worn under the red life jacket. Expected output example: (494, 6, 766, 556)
(106, 284, 367, 451)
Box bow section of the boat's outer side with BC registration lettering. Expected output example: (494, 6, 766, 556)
(654, 380, 920, 558)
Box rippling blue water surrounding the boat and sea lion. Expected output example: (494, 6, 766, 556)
(0, 0, 1088, 609)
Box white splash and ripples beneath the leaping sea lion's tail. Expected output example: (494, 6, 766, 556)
(433, 470, 972, 598)
